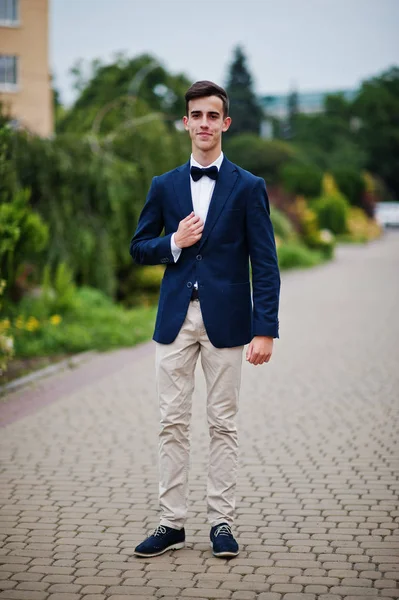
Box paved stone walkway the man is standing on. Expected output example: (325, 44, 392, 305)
(0, 232, 399, 600)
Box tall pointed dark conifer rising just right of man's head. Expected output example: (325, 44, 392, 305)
(226, 46, 263, 135)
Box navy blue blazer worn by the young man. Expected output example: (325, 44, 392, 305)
(130, 158, 280, 348)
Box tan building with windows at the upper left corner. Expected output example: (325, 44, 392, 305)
(0, 0, 53, 137)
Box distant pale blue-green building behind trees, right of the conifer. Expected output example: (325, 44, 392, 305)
(260, 90, 357, 119)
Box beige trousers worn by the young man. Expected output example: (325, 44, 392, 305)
(156, 300, 243, 529)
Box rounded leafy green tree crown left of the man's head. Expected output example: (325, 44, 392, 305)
(57, 54, 190, 134)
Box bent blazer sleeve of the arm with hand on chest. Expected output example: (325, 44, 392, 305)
(130, 177, 174, 265)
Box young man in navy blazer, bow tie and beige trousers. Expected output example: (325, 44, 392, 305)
(130, 81, 280, 557)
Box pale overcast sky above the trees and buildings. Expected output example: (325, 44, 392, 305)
(50, 0, 399, 105)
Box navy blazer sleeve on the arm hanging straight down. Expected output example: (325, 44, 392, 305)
(247, 178, 280, 338)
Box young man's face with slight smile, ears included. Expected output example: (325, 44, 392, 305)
(183, 96, 231, 152)
